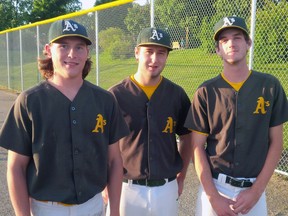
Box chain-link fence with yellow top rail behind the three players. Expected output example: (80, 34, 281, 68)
(0, 0, 288, 175)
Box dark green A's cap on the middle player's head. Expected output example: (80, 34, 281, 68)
(136, 27, 173, 51)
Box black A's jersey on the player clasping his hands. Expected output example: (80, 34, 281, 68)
(185, 71, 288, 178)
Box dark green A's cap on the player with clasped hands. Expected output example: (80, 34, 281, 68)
(214, 16, 249, 41)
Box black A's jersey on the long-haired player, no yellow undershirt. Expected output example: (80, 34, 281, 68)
(0, 81, 128, 204)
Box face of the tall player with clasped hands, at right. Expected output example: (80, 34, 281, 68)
(216, 28, 251, 64)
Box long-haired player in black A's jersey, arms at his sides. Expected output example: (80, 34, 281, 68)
(0, 20, 128, 216)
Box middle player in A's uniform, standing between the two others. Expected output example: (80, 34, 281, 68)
(105, 28, 191, 216)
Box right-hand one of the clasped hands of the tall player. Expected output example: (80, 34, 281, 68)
(233, 188, 261, 214)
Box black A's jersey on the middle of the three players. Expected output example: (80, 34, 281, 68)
(110, 77, 190, 179)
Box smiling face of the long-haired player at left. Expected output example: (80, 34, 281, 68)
(45, 37, 89, 79)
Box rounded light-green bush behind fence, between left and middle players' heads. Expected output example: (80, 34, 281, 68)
(99, 27, 133, 59)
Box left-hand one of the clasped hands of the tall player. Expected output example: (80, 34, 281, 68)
(210, 194, 237, 216)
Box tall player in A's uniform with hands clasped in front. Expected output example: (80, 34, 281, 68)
(185, 16, 288, 216)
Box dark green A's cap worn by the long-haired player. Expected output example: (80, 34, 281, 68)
(49, 20, 92, 45)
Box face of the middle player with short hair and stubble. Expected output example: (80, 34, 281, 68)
(135, 45, 168, 79)
